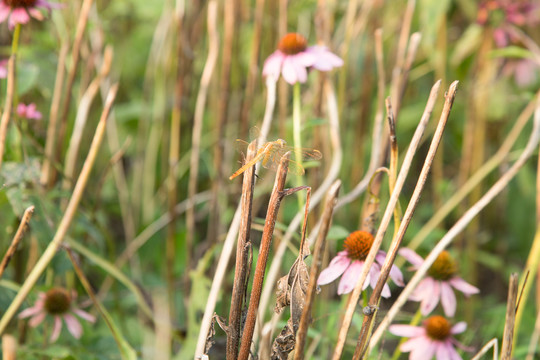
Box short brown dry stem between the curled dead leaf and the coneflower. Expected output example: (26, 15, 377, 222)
(294, 180, 341, 360)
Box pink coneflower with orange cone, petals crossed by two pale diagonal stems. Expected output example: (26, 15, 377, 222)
(317, 230, 404, 298)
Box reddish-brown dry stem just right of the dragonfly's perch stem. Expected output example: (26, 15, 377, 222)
(238, 153, 290, 360)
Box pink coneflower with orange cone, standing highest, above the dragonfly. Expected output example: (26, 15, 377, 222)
(263, 33, 343, 85)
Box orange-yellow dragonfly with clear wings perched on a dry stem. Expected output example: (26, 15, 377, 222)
(229, 139, 322, 180)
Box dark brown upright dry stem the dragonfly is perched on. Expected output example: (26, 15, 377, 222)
(227, 141, 257, 360)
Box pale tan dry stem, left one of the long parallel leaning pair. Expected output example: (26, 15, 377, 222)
(333, 81, 442, 360)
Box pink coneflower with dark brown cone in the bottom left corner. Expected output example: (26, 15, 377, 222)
(19, 288, 96, 342)
